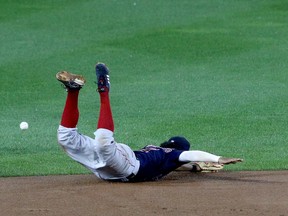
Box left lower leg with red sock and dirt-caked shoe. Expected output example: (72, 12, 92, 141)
(56, 71, 85, 128)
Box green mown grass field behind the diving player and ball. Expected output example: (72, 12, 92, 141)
(0, 0, 288, 176)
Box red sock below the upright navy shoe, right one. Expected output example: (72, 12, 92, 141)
(97, 92, 114, 132)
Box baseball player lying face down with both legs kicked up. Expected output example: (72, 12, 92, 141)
(56, 63, 242, 182)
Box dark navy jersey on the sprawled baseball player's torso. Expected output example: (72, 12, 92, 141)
(129, 145, 186, 182)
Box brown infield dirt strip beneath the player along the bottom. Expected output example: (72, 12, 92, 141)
(0, 171, 288, 216)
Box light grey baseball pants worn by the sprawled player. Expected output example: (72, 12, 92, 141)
(57, 125, 140, 181)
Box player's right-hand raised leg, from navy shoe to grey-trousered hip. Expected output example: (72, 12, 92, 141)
(95, 63, 139, 180)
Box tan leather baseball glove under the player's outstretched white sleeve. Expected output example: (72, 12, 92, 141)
(177, 162, 224, 172)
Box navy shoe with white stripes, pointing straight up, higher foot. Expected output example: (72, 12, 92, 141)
(95, 62, 110, 92)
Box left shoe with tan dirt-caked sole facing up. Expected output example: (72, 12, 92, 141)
(56, 71, 86, 90)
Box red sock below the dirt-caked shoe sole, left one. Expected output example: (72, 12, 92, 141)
(61, 90, 79, 128)
